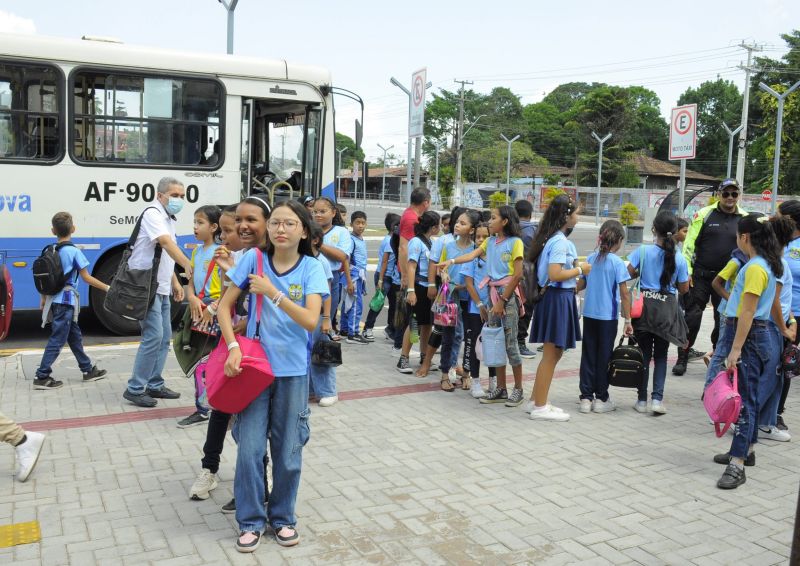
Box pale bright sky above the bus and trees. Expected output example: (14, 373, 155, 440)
(0, 0, 800, 166)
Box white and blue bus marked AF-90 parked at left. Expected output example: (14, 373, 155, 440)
(0, 34, 335, 335)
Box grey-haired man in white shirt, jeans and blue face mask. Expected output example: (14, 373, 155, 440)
(122, 177, 192, 407)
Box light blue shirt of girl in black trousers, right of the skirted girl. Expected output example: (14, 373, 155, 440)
(583, 252, 631, 320)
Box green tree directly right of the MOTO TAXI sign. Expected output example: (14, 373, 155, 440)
(678, 79, 742, 177)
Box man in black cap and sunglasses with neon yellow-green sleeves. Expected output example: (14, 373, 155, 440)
(672, 179, 747, 375)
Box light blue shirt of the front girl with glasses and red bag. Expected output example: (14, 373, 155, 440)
(228, 252, 330, 377)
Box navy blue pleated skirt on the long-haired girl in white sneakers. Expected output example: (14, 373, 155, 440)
(528, 287, 581, 350)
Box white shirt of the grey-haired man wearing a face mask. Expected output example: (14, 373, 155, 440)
(128, 202, 178, 295)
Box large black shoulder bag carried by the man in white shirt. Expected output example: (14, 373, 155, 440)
(103, 206, 161, 320)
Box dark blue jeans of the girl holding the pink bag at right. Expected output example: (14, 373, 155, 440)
(728, 320, 781, 458)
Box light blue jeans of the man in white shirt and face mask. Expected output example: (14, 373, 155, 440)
(128, 295, 172, 395)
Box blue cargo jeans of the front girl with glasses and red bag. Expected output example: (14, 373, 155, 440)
(233, 375, 311, 532)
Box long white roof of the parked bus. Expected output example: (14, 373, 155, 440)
(0, 33, 331, 86)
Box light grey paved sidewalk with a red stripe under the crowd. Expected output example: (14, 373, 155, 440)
(0, 313, 800, 566)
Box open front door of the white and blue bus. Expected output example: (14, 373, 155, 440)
(241, 99, 322, 205)
